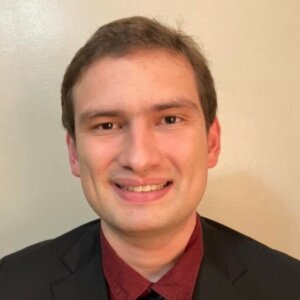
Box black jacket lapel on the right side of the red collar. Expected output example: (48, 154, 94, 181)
(193, 218, 249, 300)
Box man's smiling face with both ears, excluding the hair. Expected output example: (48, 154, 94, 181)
(67, 50, 219, 233)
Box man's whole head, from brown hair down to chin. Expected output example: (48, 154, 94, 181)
(62, 17, 220, 238)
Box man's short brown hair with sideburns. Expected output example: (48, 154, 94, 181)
(61, 16, 217, 138)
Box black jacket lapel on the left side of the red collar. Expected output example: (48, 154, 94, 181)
(52, 223, 108, 300)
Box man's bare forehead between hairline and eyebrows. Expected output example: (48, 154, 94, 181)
(73, 49, 200, 118)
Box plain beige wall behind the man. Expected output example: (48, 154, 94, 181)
(0, 0, 300, 258)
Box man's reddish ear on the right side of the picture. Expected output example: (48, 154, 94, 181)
(207, 117, 221, 168)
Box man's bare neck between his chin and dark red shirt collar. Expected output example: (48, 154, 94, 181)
(101, 214, 196, 282)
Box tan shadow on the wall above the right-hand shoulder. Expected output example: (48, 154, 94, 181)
(198, 172, 300, 257)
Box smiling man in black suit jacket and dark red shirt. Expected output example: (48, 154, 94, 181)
(0, 17, 300, 300)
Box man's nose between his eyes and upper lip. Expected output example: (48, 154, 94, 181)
(119, 124, 161, 175)
